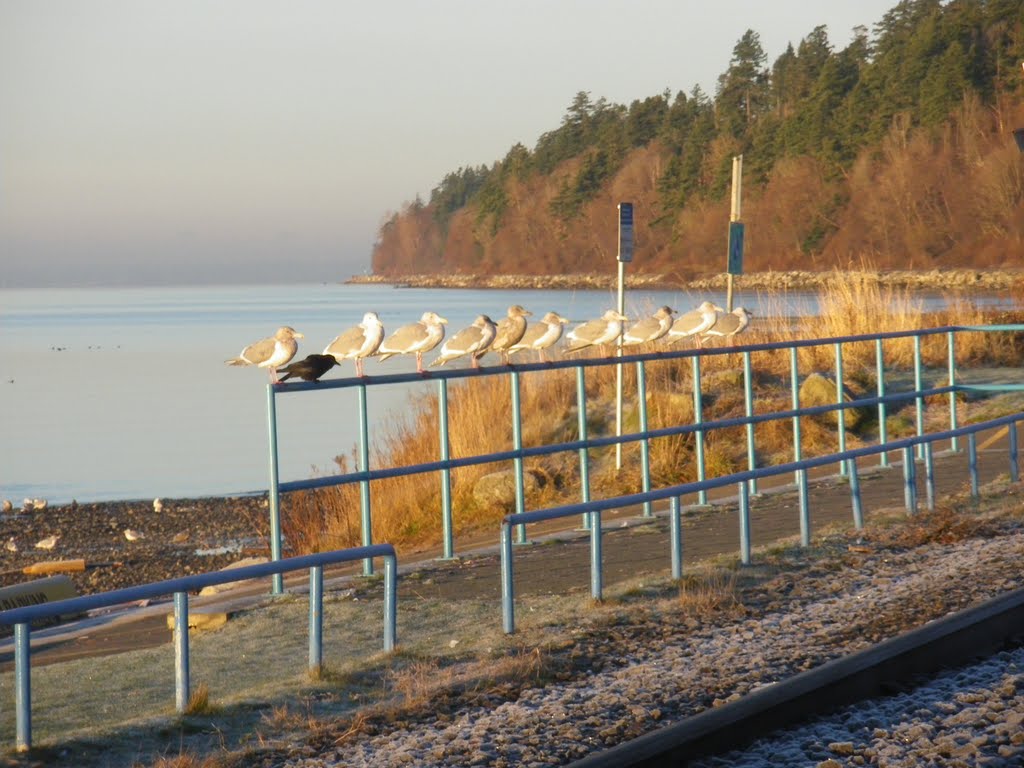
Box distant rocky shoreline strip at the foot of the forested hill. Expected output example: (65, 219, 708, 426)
(344, 269, 1024, 292)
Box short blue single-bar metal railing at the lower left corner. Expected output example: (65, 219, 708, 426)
(0, 544, 397, 751)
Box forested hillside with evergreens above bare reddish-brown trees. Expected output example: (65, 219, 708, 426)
(373, 0, 1024, 279)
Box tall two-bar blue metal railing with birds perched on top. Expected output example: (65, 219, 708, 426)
(267, 325, 1024, 591)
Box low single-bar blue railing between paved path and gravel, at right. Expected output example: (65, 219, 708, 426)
(500, 414, 1024, 634)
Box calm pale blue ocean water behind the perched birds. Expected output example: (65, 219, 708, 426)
(0, 284, 1015, 505)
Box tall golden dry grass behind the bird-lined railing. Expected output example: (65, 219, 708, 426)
(283, 271, 1022, 552)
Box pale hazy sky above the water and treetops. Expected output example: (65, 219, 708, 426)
(0, 0, 896, 288)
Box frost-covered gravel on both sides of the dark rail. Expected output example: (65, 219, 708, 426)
(259, 512, 1024, 768)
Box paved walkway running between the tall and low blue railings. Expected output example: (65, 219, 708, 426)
(0, 432, 1024, 671)
